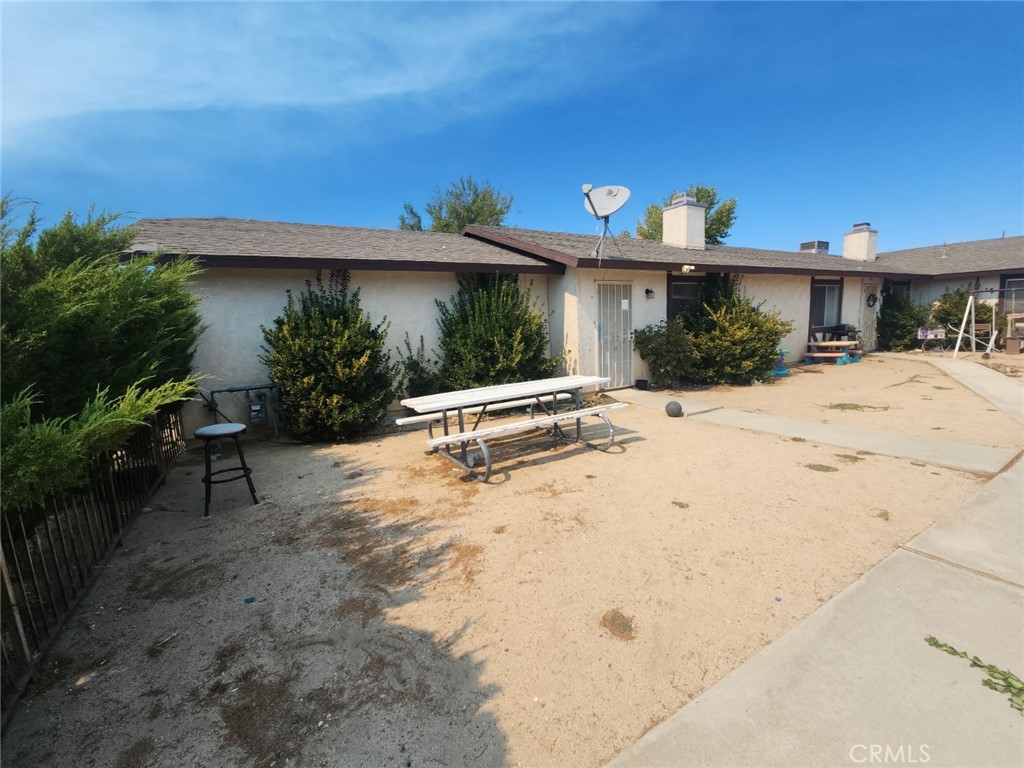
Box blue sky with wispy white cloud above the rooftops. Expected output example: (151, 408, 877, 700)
(0, 1, 1024, 252)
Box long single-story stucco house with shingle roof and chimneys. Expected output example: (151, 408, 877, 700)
(130, 196, 1024, 434)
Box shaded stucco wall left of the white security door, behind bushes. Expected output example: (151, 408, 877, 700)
(185, 269, 548, 433)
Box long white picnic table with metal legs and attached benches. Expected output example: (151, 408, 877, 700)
(395, 376, 628, 482)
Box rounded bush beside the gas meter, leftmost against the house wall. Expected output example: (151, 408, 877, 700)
(260, 271, 398, 440)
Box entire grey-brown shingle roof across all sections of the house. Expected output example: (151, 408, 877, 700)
(131, 218, 1024, 278)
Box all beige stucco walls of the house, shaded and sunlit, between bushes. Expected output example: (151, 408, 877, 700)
(185, 257, 897, 431)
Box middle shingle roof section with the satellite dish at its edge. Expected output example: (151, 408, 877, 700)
(463, 225, 921, 276)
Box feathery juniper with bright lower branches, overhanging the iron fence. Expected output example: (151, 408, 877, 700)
(0, 197, 201, 517)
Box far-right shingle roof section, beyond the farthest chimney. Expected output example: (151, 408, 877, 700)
(879, 238, 1024, 275)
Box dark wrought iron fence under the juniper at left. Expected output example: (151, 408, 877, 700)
(0, 406, 185, 723)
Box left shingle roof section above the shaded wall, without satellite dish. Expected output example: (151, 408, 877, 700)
(130, 218, 564, 272)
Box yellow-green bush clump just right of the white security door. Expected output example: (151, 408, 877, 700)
(633, 275, 793, 386)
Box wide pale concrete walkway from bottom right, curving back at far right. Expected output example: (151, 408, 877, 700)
(609, 360, 1024, 768)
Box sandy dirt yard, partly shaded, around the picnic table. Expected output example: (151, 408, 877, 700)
(3, 355, 1024, 768)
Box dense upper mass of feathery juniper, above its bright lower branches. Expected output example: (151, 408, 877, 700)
(0, 198, 202, 418)
